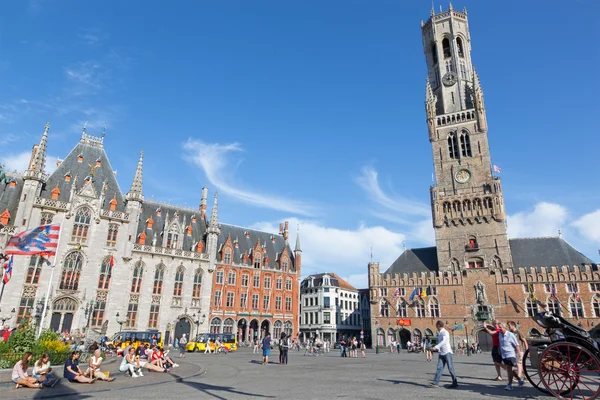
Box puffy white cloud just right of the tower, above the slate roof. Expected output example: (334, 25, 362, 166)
(508, 202, 569, 238)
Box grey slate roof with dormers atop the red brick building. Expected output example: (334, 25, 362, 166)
(217, 224, 296, 270)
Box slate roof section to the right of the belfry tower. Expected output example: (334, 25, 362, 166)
(509, 237, 594, 268)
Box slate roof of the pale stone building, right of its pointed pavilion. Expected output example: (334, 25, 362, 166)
(135, 200, 207, 251)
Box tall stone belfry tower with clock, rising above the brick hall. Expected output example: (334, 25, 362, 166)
(421, 4, 512, 271)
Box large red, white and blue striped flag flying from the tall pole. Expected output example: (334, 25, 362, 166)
(6, 224, 60, 256)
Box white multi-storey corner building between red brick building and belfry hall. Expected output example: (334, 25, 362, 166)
(300, 272, 361, 342)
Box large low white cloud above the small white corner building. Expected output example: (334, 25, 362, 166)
(253, 218, 406, 288)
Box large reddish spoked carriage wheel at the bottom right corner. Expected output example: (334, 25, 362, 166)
(539, 342, 600, 400)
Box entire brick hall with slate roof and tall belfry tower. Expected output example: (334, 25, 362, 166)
(368, 6, 600, 349)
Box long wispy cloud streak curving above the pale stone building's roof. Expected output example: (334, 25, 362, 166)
(183, 139, 315, 216)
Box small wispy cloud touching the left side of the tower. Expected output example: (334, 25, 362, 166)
(356, 166, 431, 223)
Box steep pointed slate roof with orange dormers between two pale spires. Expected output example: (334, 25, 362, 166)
(40, 134, 125, 211)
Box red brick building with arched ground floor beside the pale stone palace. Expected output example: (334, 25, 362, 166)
(210, 221, 302, 341)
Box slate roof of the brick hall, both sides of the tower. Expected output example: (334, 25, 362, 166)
(385, 237, 594, 274)
